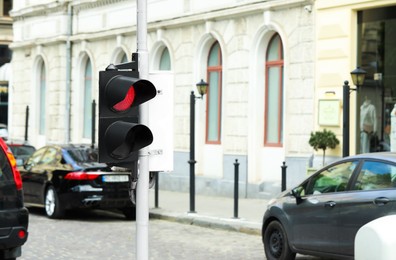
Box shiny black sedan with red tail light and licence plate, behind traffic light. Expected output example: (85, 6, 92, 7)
(20, 145, 136, 219)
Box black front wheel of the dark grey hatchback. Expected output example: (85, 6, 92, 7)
(263, 221, 296, 260)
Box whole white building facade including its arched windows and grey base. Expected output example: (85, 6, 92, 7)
(9, 0, 318, 197)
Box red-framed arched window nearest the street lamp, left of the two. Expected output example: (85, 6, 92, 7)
(206, 42, 223, 144)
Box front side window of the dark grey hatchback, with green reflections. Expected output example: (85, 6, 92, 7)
(306, 161, 358, 194)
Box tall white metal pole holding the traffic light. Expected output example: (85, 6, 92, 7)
(136, 0, 149, 260)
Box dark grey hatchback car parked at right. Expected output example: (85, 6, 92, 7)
(262, 152, 396, 260)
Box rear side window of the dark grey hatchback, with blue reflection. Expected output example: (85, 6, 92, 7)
(353, 161, 396, 190)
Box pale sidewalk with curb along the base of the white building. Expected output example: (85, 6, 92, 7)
(149, 189, 268, 235)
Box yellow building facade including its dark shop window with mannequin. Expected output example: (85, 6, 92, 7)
(315, 0, 396, 158)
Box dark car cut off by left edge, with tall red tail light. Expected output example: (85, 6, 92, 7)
(0, 138, 29, 259)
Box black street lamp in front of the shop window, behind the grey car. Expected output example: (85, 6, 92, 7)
(342, 67, 367, 157)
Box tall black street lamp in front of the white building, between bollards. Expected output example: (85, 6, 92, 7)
(188, 79, 208, 213)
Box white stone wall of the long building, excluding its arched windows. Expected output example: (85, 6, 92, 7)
(11, 0, 314, 198)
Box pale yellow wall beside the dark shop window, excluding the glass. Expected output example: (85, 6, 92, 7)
(315, 0, 396, 156)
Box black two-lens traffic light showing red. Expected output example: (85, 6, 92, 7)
(99, 61, 157, 167)
